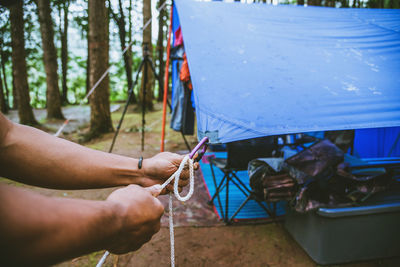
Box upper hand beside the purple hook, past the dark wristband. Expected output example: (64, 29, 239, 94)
(139, 152, 199, 194)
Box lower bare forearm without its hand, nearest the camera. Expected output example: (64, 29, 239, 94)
(0, 185, 122, 266)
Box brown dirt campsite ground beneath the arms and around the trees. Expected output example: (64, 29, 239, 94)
(1, 105, 400, 267)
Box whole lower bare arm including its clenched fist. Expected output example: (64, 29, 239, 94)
(0, 185, 164, 266)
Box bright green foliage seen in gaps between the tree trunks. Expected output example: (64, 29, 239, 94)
(0, 0, 150, 108)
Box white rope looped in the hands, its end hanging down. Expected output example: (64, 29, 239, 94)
(96, 155, 194, 267)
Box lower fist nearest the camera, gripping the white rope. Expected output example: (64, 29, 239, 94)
(106, 185, 164, 254)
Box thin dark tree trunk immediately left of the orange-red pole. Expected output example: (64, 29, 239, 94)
(157, 0, 167, 102)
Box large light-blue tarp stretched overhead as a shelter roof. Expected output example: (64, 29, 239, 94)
(175, 0, 400, 143)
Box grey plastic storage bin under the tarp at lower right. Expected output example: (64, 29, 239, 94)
(285, 198, 400, 264)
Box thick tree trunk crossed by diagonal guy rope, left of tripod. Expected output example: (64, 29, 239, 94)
(88, 0, 113, 137)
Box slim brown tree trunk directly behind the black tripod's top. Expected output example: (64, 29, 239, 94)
(140, 0, 154, 110)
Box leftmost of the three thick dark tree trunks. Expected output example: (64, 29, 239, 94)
(10, 1, 38, 125)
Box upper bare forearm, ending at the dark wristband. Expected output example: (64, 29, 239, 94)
(0, 114, 143, 189)
